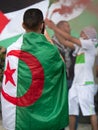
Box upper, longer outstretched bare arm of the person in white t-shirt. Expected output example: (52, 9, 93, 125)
(45, 19, 81, 46)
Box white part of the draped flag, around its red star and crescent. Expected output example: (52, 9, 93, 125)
(1, 37, 23, 130)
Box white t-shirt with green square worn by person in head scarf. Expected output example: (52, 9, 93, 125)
(73, 39, 96, 85)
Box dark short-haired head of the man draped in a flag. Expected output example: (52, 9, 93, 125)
(22, 8, 44, 33)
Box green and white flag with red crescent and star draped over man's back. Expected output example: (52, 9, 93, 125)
(1, 32, 68, 130)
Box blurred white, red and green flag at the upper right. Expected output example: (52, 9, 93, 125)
(47, 0, 98, 37)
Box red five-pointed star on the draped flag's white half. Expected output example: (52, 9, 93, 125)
(4, 61, 16, 86)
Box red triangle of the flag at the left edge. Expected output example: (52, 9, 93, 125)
(0, 11, 10, 33)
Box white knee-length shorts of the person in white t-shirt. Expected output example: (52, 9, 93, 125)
(69, 84, 95, 116)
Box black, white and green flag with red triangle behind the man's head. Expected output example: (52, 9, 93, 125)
(0, 0, 49, 48)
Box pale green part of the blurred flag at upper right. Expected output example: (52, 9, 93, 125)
(69, 0, 98, 35)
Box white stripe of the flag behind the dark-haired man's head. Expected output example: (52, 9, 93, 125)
(0, 0, 49, 40)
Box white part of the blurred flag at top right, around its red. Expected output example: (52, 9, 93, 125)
(47, 0, 85, 24)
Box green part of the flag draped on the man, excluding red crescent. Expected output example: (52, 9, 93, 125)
(15, 33, 69, 130)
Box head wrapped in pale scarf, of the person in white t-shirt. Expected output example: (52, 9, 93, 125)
(80, 26, 97, 40)
